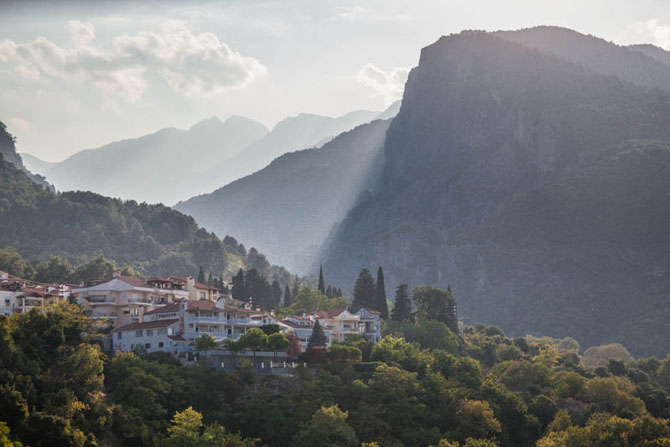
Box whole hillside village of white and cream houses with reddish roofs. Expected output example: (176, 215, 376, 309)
(0, 271, 381, 364)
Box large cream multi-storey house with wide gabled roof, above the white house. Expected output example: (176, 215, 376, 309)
(72, 274, 189, 327)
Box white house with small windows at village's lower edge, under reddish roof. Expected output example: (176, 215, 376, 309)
(112, 318, 186, 353)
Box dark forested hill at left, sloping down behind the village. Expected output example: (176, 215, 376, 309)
(0, 122, 289, 284)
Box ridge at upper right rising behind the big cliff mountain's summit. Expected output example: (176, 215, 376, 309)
(496, 26, 670, 90)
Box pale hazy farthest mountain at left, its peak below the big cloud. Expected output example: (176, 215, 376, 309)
(25, 117, 267, 204)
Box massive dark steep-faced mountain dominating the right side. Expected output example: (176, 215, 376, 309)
(321, 29, 670, 354)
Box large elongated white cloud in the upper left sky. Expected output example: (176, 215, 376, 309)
(0, 20, 266, 107)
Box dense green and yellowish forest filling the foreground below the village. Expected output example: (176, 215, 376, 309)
(0, 294, 670, 447)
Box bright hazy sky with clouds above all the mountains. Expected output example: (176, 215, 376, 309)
(0, 0, 670, 161)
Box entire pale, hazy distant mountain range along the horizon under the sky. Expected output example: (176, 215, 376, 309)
(24, 110, 379, 204)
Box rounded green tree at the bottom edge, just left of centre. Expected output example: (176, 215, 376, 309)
(294, 405, 359, 447)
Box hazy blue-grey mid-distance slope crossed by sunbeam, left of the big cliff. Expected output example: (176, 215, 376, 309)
(175, 120, 389, 269)
